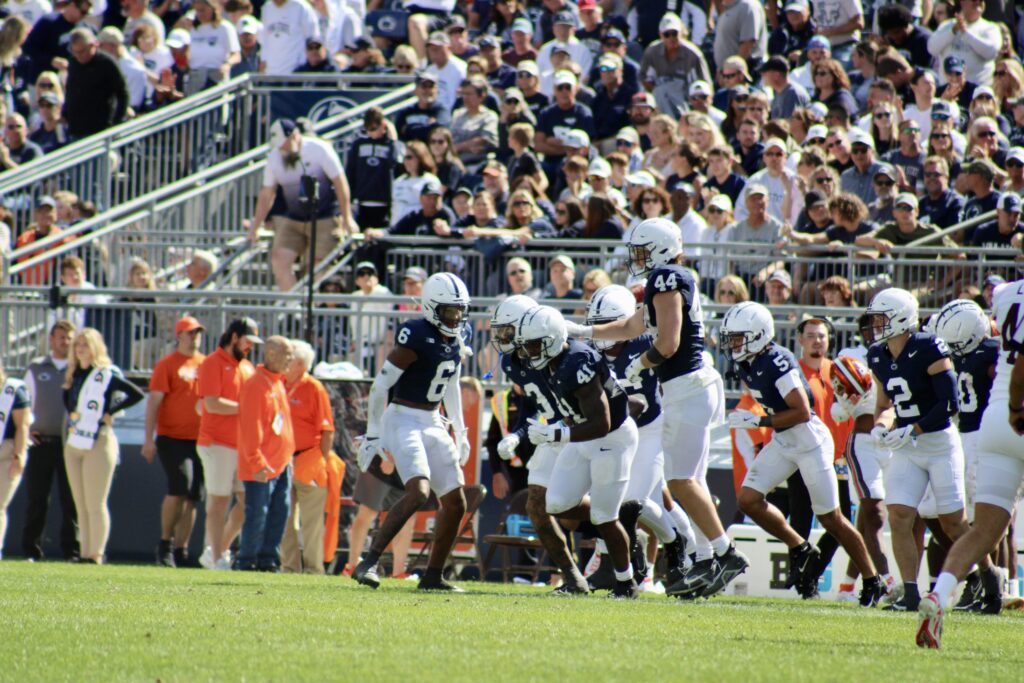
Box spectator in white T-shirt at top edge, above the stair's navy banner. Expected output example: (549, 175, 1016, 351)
(259, 0, 321, 75)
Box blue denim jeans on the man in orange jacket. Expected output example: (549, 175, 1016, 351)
(236, 465, 292, 569)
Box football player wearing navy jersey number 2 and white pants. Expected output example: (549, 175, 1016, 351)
(865, 288, 968, 611)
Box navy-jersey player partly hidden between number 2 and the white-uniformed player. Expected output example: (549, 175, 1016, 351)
(933, 299, 1003, 611)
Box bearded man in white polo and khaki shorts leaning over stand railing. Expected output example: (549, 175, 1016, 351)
(249, 119, 359, 292)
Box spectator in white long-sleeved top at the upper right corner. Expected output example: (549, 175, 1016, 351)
(928, 0, 1002, 85)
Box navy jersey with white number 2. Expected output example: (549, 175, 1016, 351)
(867, 332, 956, 431)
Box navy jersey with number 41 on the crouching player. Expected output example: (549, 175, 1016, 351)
(545, 339, 629, 431)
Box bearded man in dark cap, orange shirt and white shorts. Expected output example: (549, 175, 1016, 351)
(197, 317, 263, 569)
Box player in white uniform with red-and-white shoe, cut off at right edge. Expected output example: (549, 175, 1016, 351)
(916, 280, 1024, 648)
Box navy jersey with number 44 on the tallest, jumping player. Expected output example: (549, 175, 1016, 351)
(643, 265, 703, 382)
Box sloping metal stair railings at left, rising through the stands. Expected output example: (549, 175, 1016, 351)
(0, 75, 412, 289)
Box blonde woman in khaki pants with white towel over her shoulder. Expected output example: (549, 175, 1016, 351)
(63, 328, 145, 564)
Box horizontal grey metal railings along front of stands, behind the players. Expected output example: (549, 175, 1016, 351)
(0, 231, 1020, 384)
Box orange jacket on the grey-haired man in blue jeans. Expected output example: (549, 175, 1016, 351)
(238, 366, 295, 481)
